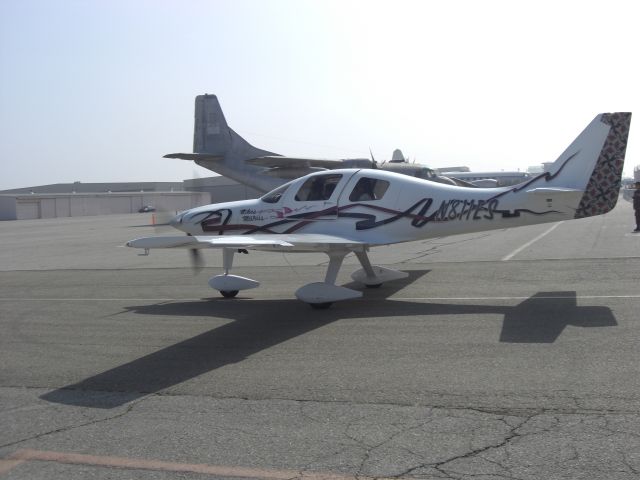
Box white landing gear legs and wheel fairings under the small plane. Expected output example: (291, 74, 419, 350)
(209, 248, 408, 309)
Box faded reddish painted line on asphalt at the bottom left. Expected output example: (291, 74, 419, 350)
(6, 449, 392, 480)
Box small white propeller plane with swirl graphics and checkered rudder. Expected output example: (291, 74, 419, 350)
(127, 113, 631, 308)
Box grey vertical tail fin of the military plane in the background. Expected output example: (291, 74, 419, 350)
(193, 94, 275, 159)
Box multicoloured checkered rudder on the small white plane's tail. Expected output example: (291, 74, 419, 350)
(575, 113, 631, 218)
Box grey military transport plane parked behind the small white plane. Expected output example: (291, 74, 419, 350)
(164, 94, 473, 192)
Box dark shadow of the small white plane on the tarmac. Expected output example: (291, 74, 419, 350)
(41, 270, 617, 408)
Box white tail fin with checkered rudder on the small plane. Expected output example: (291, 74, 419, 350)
(547, 112, 631, 218)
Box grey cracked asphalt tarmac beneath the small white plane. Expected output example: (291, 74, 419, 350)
(0, 200, 640, 480)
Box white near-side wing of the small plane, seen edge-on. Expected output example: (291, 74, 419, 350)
(126, 234, 365, 252)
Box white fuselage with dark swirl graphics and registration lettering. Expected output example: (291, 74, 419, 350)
(172, 169, 579, 245)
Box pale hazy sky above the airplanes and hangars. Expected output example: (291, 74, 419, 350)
(0, 0, 640, 189)
